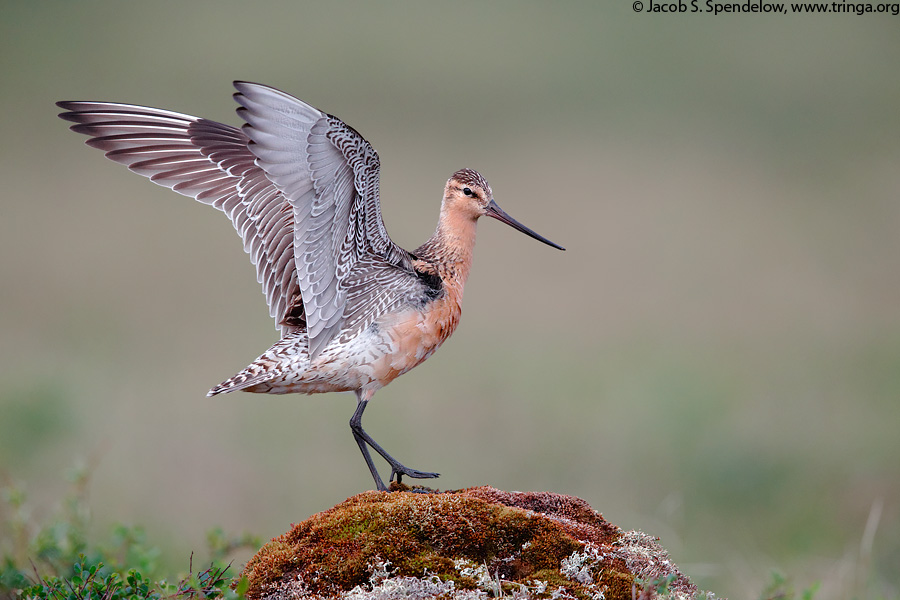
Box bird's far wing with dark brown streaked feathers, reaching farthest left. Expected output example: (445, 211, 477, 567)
(57, 102, 303, 335)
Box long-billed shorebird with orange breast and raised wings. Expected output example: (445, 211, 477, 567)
(57, 81, 565, 491)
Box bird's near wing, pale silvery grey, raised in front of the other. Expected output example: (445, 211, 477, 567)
(234, 82, 418, 356)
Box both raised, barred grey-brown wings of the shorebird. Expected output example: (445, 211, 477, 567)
(58, 82, 420, 358)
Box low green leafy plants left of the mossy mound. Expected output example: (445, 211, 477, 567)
(0, 468, 253, 600)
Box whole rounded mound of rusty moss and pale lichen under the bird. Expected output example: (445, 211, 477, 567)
(243, 486, 697, 600)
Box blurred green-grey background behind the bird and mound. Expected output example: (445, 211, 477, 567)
(0, 0, 900, 598)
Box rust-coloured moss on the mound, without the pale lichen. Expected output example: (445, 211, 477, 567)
(243, 488, 688, 600)
